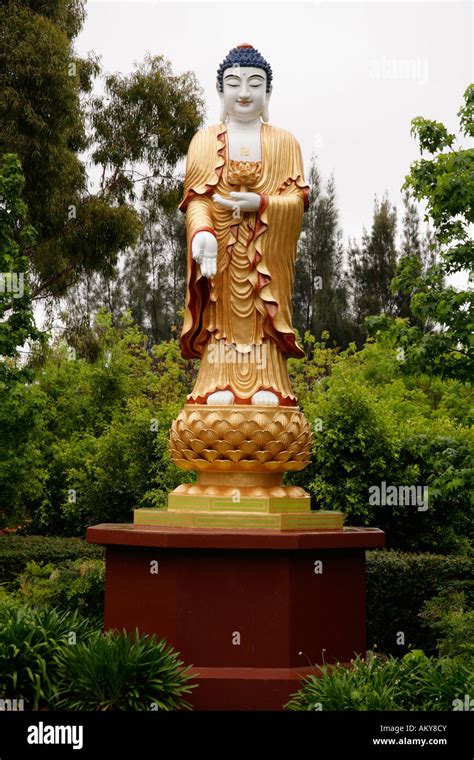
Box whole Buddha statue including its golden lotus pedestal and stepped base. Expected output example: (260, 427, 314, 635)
(134, 44, 343, 531)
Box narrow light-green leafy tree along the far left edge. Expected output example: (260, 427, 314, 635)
(0, 153, 45, 528)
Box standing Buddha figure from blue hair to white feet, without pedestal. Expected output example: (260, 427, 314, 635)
(179, 44, 309, 406)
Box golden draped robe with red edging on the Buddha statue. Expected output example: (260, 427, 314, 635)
(179, 123, 309, 406)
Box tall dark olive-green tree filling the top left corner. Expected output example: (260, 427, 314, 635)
(0, 0, 139, 298)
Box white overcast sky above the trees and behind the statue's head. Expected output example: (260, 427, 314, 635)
(76, 0, 473, 266)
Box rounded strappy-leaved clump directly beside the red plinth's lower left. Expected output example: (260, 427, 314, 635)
(52, 630, 197, 711)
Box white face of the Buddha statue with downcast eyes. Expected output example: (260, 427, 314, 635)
(219, 65, 270, 121)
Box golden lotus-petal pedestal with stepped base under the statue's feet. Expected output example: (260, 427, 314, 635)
(134, 404, 343, 530)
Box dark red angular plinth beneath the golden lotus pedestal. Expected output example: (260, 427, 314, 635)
(87, 525, 384, 710)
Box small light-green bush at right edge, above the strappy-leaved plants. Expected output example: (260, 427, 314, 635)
(420, 591, 474, 663)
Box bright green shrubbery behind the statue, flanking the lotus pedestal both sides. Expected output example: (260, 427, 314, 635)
(0, 314, 472, 553)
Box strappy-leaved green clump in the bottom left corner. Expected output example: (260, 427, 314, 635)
(0, 595, 92, 709)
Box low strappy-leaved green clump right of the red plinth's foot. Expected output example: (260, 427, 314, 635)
(285, 650, 474, 712)
